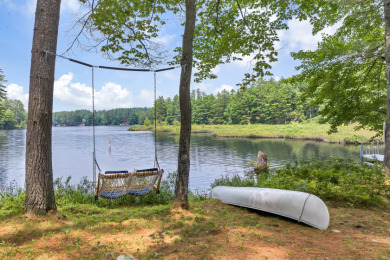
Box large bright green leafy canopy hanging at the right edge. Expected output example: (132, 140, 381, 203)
(292, 0, 387, 132)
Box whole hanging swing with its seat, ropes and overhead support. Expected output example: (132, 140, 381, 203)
(42, 50, 181, 200)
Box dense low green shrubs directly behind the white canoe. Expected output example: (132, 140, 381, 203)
(212, 159, 390, 206)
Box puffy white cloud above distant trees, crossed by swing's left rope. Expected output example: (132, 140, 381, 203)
(54, 73, 133, 110)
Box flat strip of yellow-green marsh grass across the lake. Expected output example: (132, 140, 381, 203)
(129, 123, 380, 143)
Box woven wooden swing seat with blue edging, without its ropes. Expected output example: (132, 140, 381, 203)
(95, 168, 164, 199)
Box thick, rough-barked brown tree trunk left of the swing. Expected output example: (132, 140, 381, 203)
(25, 0, 61, 215)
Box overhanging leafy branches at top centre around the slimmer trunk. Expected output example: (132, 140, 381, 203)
(80, 0, 298, 85)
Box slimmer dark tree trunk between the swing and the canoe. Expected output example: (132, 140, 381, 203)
(174, 0, 196, 209)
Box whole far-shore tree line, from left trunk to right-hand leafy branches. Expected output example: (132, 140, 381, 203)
(49, 79, 318, 126)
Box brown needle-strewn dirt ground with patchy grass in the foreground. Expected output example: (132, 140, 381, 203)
(0, 199, 390, 259)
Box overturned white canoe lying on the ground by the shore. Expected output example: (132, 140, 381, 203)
(212, 186, 329, 230)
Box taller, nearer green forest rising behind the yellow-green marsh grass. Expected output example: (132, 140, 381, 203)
(156, 79, 318, 125)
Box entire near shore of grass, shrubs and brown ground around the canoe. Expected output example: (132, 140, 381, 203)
(0, 161, 390, 259)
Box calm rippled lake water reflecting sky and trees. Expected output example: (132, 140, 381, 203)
(0, 126, 374, 191)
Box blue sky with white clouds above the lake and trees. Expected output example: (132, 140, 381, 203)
(0, 0, 337, 112)
